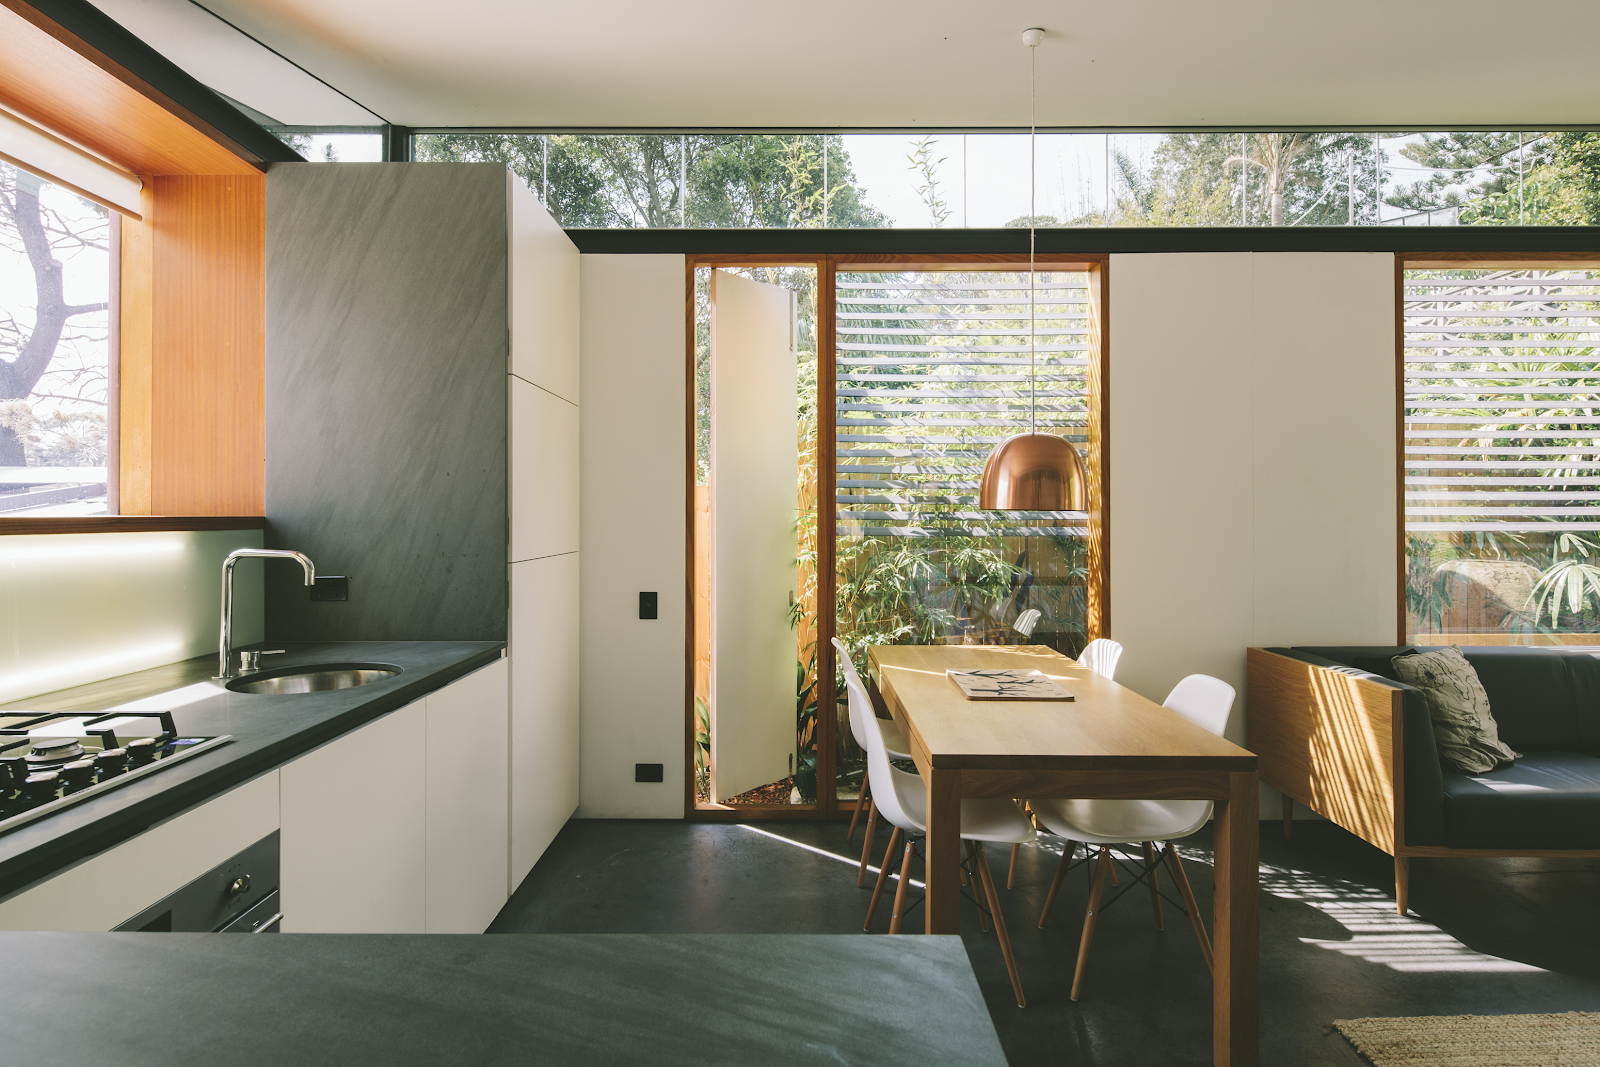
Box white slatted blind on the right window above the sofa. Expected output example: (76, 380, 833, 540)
(1402, 270, 1600, 533)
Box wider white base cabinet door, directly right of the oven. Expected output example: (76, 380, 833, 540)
(278, 697, 432, 934)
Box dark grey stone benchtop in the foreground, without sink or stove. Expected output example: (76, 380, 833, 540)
(0, 933, 1005, 1067)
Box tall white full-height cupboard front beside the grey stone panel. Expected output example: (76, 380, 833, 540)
(507, 181, 579, 889)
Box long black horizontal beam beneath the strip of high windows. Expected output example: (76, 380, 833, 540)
(566, 226, 1600, 258)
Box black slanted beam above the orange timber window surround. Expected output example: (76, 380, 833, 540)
(0, 0, 304, 170)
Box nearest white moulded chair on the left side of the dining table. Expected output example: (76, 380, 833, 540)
(846, 681, 1035, 1008)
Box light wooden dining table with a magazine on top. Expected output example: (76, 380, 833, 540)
(867, 645, 1259, 1067)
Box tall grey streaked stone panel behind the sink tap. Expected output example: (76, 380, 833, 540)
(266, 163, 507, 641)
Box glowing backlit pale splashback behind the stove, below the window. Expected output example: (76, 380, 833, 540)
(0, 530, 261, 702)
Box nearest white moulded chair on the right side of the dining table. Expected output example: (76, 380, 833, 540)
(1030, 675, 1235, 1000)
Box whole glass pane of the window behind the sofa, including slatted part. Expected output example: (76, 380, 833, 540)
(1403, 269, 1600, 645)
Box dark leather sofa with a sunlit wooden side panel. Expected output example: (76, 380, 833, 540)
(1250, 646, 1600, 912)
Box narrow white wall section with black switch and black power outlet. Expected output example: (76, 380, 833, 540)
(578, 256, 688, 819)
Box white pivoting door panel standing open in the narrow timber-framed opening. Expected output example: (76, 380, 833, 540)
(710, 270, 800, 800)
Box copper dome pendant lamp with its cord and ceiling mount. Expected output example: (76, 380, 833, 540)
(978, 27, 1088, 512)
